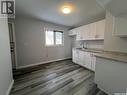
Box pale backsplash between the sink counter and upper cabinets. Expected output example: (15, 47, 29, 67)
(72, 38, 104, 49)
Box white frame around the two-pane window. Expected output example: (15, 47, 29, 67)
(44, 29, 64, 47)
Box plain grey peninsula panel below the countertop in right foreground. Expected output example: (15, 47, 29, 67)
(95, 57, 127, 95)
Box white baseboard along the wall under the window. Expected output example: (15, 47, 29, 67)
(16, 57, 71, 69)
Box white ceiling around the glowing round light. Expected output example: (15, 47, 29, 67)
(16, 0, 105, 27)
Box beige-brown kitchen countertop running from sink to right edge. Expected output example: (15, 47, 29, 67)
(74, 48, 127, 63)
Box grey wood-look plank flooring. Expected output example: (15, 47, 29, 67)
(10, 60, 106, 95)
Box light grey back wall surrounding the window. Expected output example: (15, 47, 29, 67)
(15, 17, 71, 67)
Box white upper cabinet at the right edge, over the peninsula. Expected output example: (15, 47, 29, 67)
(113, 16, 127, 37)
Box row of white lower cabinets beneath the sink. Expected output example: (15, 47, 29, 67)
(72, 49, 96, 71)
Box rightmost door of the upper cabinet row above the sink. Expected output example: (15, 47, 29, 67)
(96, 20, 105, 39)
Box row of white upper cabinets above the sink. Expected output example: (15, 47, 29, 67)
(70, 20, 105, 40)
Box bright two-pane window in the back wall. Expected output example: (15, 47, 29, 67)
(45, 30, 63, 46)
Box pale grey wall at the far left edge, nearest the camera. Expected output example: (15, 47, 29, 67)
(0, 18, 13, 95)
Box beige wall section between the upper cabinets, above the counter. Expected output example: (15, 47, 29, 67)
(104, 11, 127, 53)
